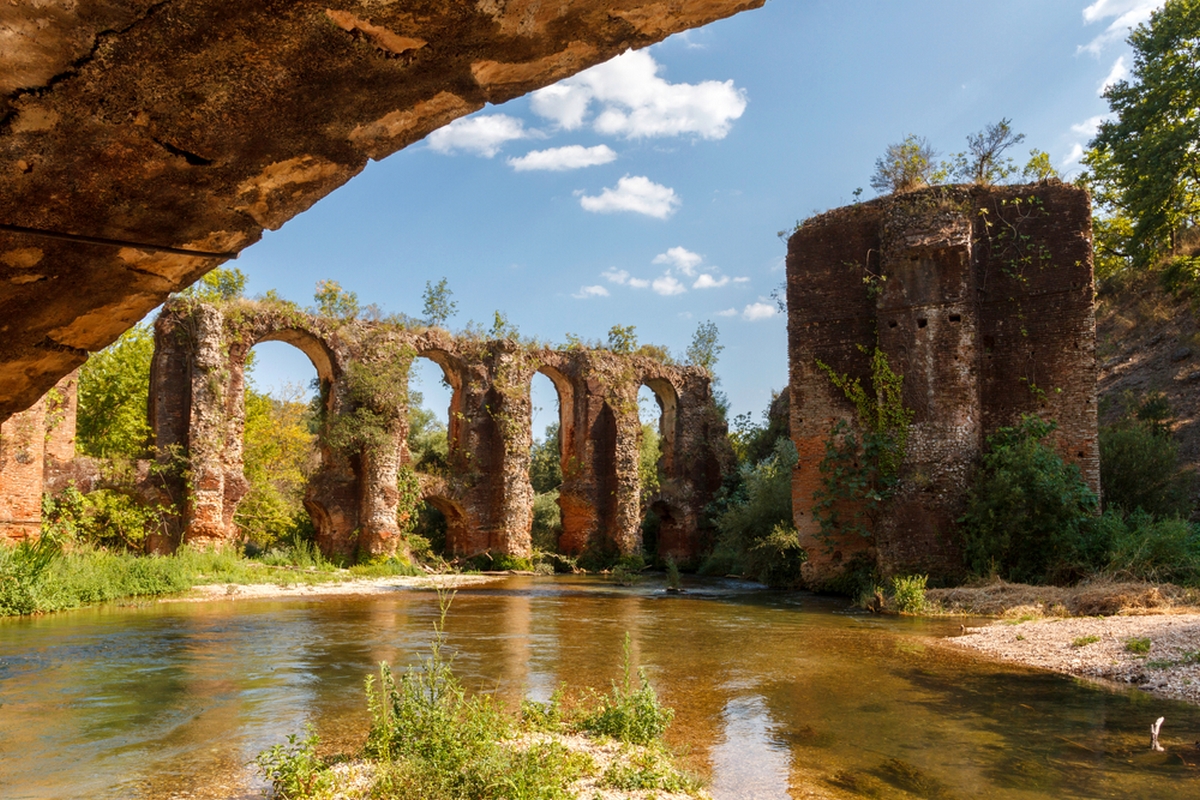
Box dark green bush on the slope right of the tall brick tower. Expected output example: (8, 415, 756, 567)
(1100, 393, 1195, 517)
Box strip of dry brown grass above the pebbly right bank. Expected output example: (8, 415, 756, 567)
(925, 579, 1200, 620)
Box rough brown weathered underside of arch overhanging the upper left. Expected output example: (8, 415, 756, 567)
(0, 0, 764, 419)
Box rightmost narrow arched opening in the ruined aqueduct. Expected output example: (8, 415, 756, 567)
(637, 378, 678, 557)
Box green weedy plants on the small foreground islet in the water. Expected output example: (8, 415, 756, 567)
(257, 595, 698, 800)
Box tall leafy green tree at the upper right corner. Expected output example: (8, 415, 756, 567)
(1084, 0, 1200, 266)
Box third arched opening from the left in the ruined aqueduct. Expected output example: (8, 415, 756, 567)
(529, 367, 572, 553)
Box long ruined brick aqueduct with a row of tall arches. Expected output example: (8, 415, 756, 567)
(0, 300, 731, 559)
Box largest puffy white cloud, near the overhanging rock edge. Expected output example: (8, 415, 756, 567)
(529, 50, 746, 139)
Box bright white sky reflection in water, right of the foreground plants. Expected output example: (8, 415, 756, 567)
(709, 694, 792, 800)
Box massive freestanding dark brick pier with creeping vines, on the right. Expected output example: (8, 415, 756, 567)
(787, 182, 1099, 584)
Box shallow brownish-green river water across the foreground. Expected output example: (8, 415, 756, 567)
(0, 577, 1200, 800)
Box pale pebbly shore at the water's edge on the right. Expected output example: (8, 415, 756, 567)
(947, 612, 1200, 704)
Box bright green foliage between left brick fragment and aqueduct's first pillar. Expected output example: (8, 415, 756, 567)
(76, 321, 152, 458)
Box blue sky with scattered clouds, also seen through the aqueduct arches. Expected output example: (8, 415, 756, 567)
(234, 0, 1160, 432)
